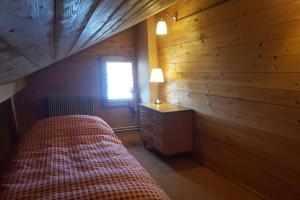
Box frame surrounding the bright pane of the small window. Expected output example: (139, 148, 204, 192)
(100, 56, 136, 107)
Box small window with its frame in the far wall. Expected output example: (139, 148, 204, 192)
(101, 57, 134, 106)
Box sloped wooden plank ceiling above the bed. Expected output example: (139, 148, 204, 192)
(0, 0, 176, 84)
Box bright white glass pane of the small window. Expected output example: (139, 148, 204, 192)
(106, 62, 133, 100)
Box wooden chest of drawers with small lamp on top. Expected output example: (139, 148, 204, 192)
(139, 103, 193, 156)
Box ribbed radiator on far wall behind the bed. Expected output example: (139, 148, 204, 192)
(48, 94, 94, 117)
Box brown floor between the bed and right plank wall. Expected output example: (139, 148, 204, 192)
(117, 131, 261, 200)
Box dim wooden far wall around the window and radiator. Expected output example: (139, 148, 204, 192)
(15, 29, 137, 132)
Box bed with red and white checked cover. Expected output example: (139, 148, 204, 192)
(0, 115, 169, 200)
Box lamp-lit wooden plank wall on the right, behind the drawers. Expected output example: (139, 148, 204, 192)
(156, 0, 300, 200)
